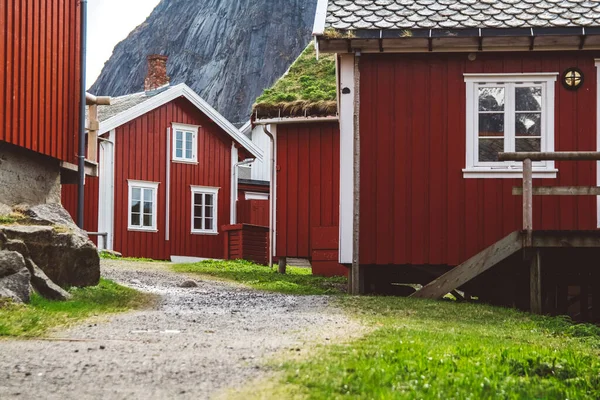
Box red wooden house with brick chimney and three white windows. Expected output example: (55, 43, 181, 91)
(63, 56, 262, 260)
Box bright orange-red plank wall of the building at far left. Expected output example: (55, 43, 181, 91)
(0, 0, 80, 163)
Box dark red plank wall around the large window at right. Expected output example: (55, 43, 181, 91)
(360, 52, 600, 265)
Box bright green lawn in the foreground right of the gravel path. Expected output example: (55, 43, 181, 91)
(281, 297, 600, 399)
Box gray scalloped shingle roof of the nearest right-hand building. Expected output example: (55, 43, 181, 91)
(325, 0, 600, 30)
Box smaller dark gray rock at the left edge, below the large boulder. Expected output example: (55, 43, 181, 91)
(0, 250, 30, 303)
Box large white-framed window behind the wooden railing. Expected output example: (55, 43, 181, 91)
(463, 73, 558, 178)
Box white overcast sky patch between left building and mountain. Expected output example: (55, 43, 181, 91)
(86, 0, 160, 88)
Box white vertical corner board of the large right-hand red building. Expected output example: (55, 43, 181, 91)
(338, 54, 355, 264)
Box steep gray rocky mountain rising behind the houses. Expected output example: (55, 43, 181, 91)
(90, 0, 317, 124)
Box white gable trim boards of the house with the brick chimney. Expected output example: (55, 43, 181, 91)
(98, 83, 263, 160)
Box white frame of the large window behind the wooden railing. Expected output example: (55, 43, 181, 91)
(463, 72, 559, 178)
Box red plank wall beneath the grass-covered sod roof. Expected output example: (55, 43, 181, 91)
(276, 123, 340, 258)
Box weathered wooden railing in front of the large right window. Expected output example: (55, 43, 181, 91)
(498, 151, 600, 247)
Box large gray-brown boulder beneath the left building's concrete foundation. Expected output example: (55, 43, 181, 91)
(0, 225, 100, 287)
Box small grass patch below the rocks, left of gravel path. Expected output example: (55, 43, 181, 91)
(0, 279, 153, 337)
